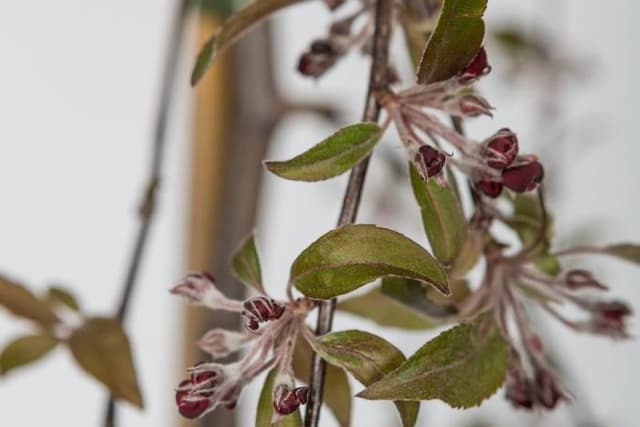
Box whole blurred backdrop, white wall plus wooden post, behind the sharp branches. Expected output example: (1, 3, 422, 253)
(0, 0, 640, 427)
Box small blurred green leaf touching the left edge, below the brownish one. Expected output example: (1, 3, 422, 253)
(0, 334, 58, 375)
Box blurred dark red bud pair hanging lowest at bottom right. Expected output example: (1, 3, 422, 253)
(505, 356, 569, 409)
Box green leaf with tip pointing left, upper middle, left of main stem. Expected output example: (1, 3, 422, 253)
(265, 123, 382, 181)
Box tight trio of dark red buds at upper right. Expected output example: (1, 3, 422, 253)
(475, 128, 544, 198)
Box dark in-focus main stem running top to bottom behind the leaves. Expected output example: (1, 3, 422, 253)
(305, 0, 392, 427)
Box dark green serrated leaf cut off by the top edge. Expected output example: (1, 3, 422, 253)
(418, 0, 487, 84)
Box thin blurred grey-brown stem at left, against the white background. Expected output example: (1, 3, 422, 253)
(104, 0, 191, 427)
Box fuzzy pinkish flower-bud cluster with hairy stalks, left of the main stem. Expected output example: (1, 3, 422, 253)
(171, 273, 313, 421)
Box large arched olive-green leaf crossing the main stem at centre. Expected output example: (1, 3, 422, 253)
(289, 224, 449, 298)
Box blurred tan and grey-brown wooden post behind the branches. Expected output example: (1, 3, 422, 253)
(182, 11, 279, 427)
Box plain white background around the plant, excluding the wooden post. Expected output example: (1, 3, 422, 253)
(0, 0, 640, 427)
